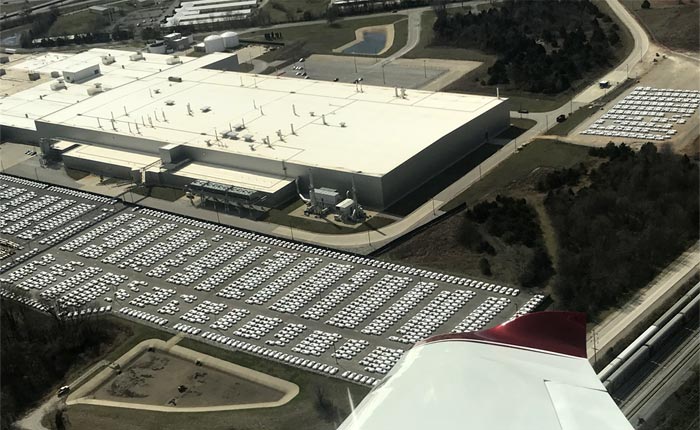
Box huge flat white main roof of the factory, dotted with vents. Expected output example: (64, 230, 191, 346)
(0, 50, 504, 176)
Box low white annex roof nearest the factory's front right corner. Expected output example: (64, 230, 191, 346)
(171, 162, 293, 194)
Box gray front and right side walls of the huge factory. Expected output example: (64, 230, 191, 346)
(28, 99, 510, 209)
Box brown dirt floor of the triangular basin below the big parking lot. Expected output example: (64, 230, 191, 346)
(93, 350, 283, 407)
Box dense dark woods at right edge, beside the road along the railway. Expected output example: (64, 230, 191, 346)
(545, 143, 700, 317)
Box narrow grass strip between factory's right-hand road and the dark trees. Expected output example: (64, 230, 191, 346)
(442, 139, 591, 210)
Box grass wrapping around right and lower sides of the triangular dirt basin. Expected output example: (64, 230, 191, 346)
(67, 339, 369, 430)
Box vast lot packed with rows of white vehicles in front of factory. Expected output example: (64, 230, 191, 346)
(0, 175, 543, 385)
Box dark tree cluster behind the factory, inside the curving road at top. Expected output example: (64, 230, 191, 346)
(433, 0, 620, 94)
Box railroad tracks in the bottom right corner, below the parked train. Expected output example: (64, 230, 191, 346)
(620, 329, 700, 420)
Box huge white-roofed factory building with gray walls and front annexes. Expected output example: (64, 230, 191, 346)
(0, 49, 509, 210)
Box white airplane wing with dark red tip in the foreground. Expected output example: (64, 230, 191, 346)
(338, 312, 632, 430)
